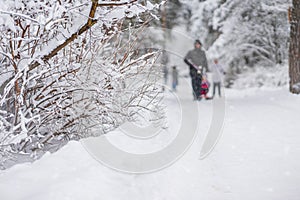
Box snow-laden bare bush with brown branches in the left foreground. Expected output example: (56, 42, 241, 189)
(0, 0, 162, 168)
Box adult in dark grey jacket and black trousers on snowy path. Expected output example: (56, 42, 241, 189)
(184, 40, 208, 100)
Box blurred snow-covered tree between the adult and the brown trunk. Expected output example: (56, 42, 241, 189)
(182, 0, 290, 70)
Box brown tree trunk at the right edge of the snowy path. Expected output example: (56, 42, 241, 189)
(289, 0, 300, 94)
